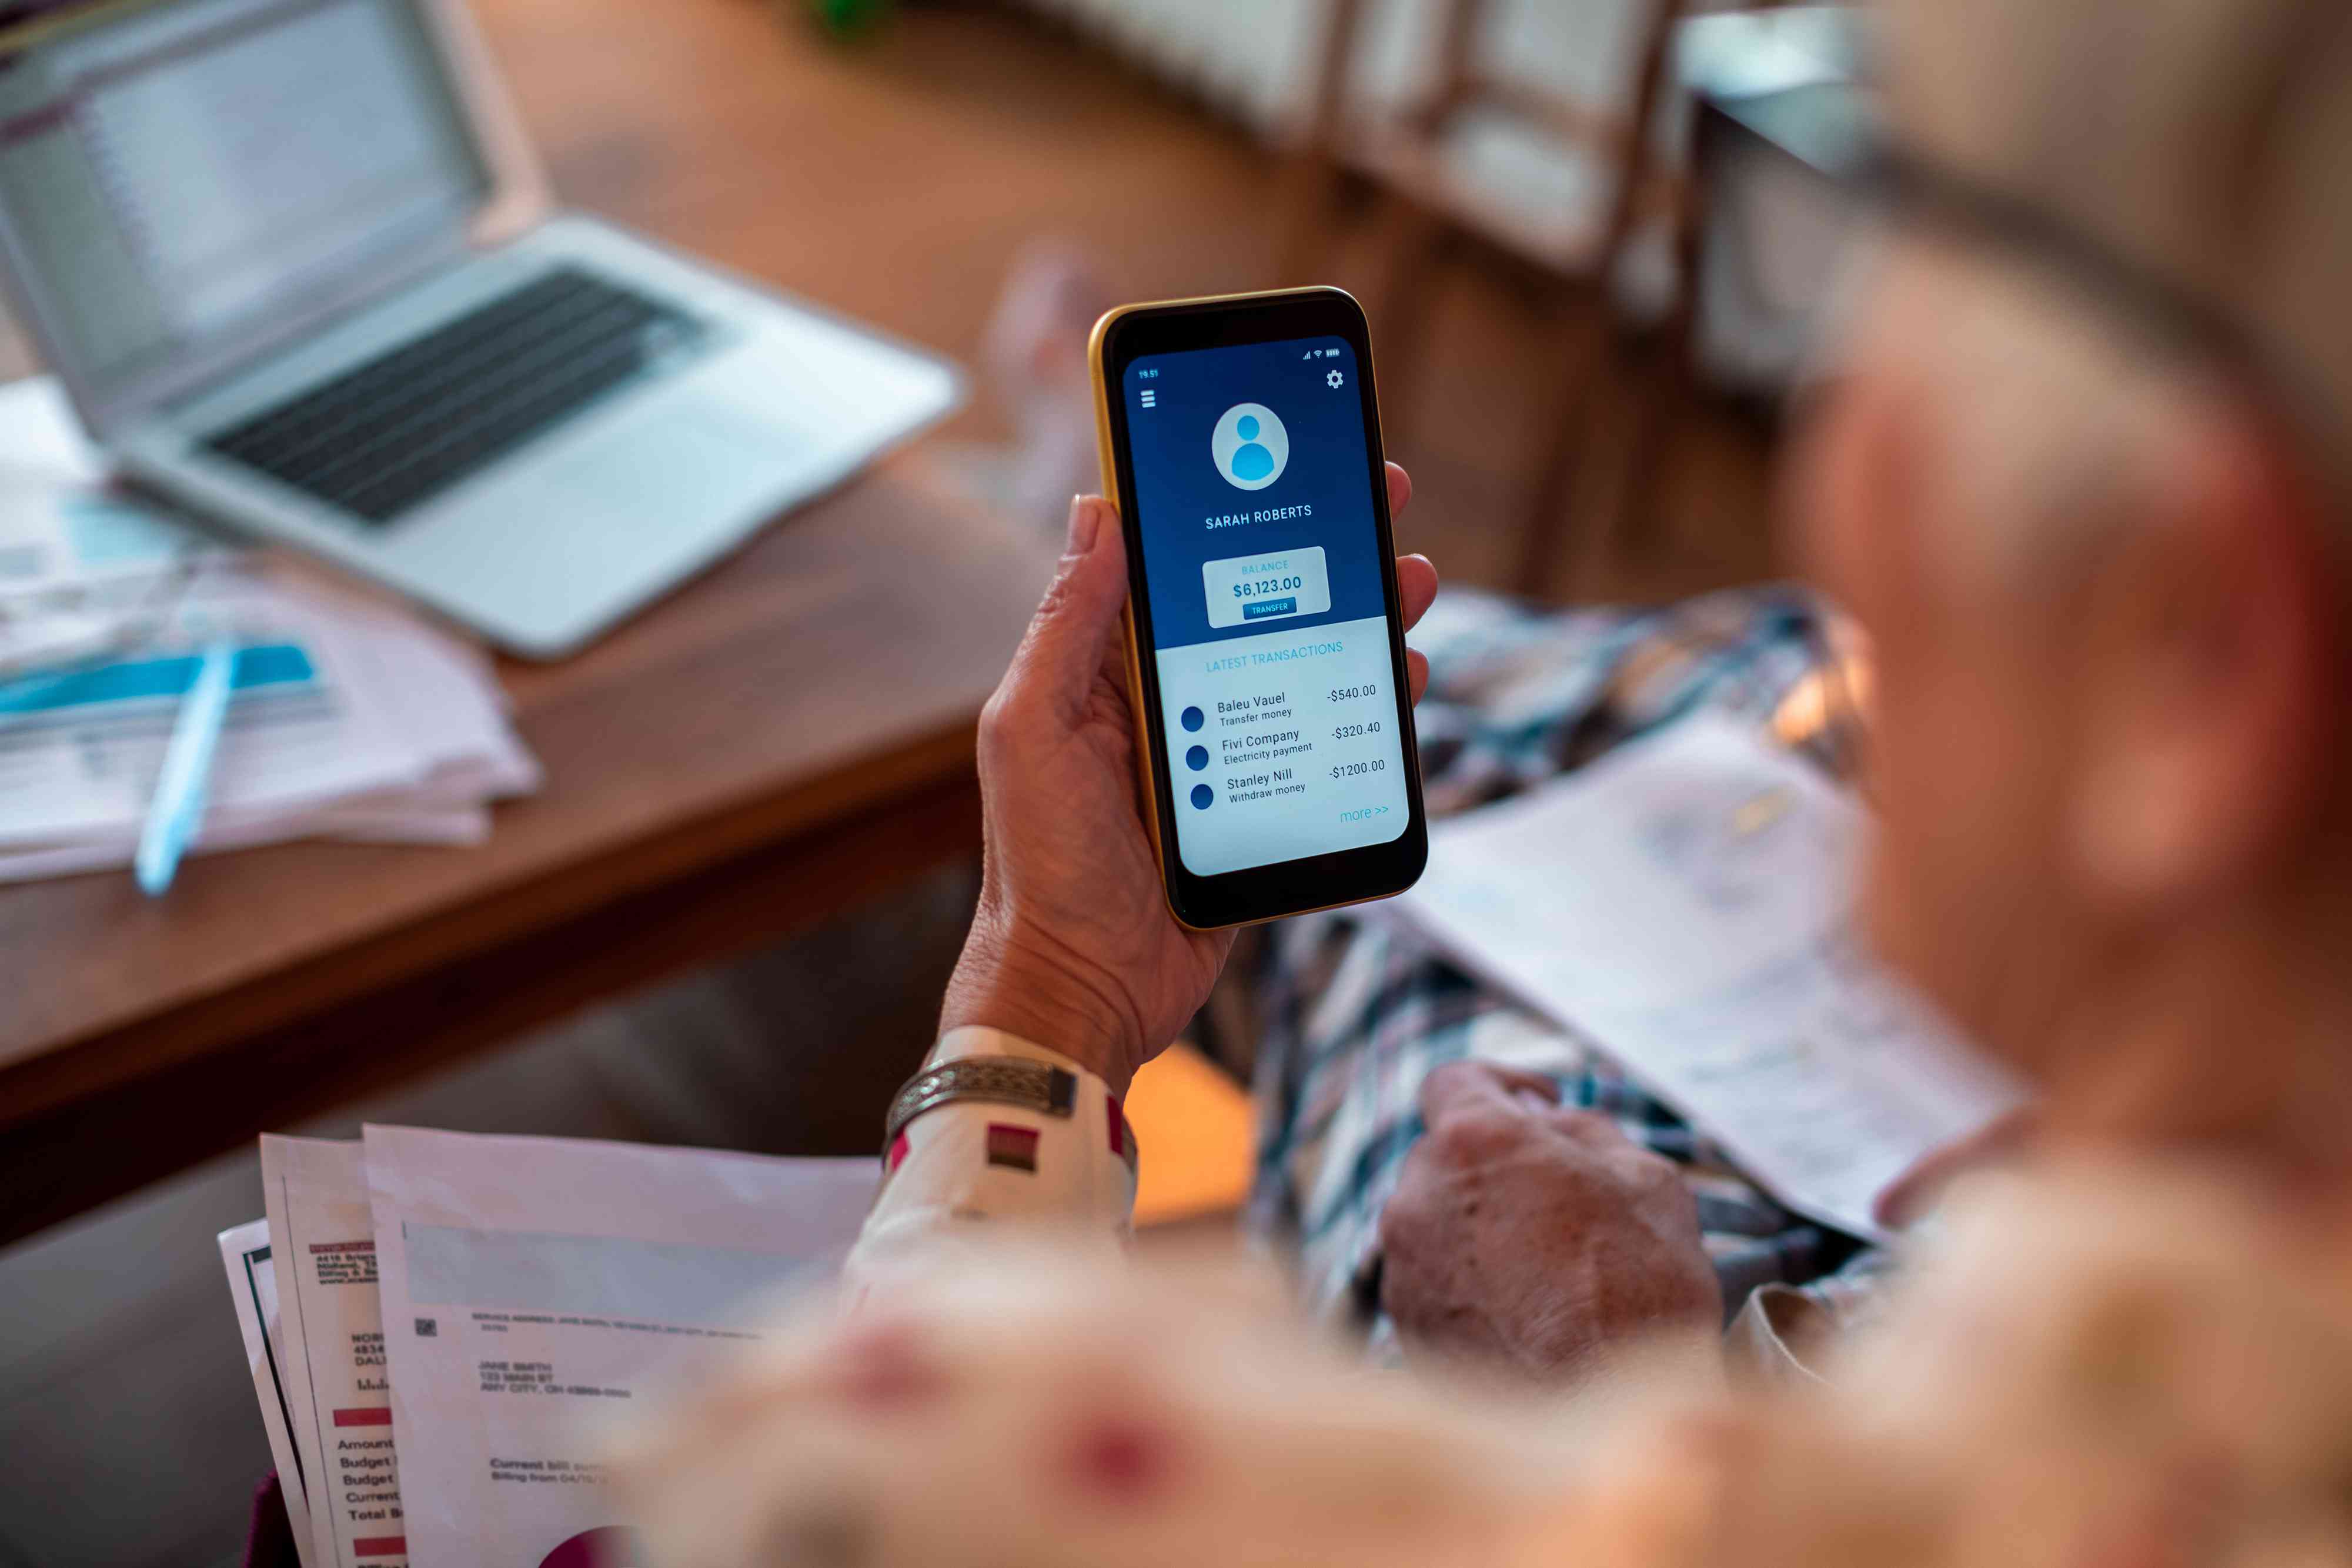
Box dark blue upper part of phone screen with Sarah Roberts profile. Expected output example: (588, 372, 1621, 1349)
(1122, 339, 1388, 649)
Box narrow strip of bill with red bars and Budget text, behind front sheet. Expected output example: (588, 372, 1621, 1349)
(261, 1135, 409, 1568)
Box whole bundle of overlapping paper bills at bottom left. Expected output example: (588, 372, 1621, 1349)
(221, 1126, 880, 1568)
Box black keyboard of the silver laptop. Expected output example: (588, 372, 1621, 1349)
(205, 268, 701, 524)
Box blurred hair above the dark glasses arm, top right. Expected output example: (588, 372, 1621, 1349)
(1884, 0, 2352, 477)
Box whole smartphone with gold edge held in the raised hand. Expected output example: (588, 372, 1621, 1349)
(1091, 289, 1430, 931)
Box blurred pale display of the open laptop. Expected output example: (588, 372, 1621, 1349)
(0, 0, 489, 411)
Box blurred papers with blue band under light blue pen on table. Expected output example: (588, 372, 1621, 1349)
(0, 381, 539, 879)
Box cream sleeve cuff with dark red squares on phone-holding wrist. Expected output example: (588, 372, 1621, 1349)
(842, 1027, 1136, 1309)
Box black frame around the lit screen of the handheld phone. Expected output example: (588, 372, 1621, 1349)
(1101, 289, 1430, 928)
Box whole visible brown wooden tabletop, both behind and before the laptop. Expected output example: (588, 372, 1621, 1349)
(0, 0, 1115, 1243)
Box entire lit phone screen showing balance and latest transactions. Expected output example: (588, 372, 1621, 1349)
(1120, 339, 1409, 877)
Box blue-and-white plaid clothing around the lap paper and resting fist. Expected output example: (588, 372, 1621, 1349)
(1251, 588, 1879, 1356)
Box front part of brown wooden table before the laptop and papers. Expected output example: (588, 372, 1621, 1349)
(0, 459, 1051, 1241)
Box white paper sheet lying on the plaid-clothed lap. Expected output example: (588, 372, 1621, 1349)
(1395, 715, 2016, 1236)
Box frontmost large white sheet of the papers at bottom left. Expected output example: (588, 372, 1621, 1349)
(367, 1126, 880, 1568)
